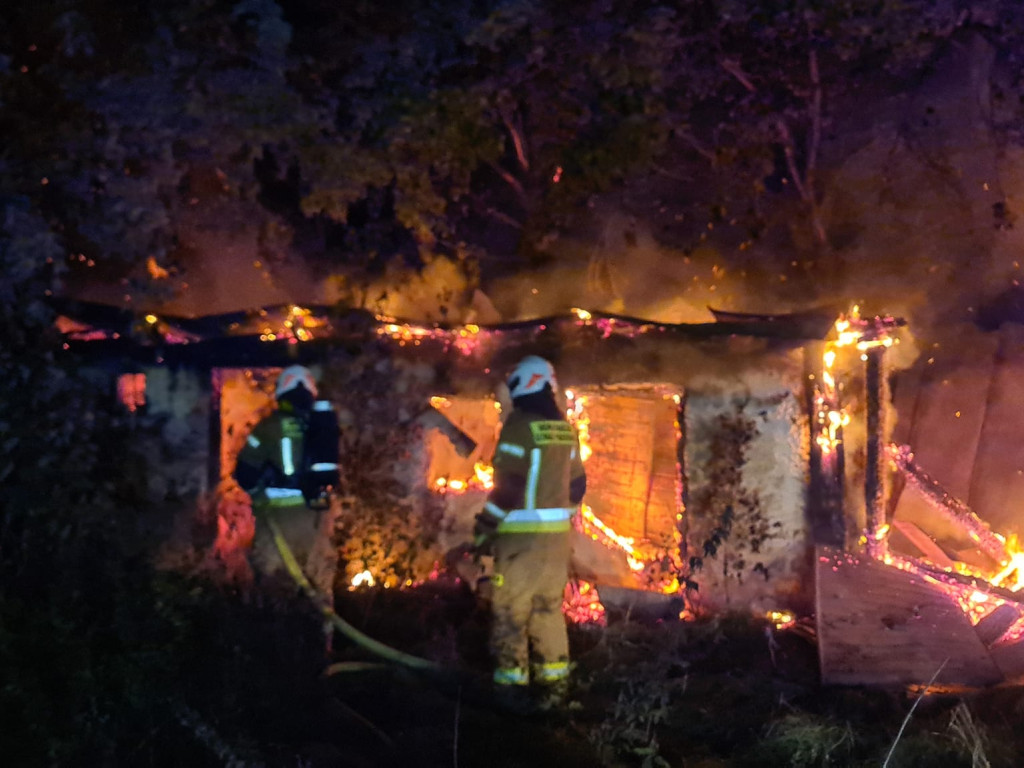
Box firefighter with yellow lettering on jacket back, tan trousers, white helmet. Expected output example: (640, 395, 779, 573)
(473, 355, 587, 689)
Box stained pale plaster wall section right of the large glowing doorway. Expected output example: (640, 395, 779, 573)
(684, 376, 812, 611)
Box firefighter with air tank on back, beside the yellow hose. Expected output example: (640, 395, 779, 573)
(234, 366, 340, 596)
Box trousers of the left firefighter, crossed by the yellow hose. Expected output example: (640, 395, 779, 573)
(249, 497, 338, 600)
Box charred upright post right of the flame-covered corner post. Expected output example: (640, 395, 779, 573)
(864, 346, 889, 558)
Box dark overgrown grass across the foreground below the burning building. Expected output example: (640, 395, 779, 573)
(8, 540, 1024, 768)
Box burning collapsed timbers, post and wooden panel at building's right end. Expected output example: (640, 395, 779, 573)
(798, 307, 1024, 687)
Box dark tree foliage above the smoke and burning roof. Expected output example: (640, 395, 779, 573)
(0, 0, 1022, 313)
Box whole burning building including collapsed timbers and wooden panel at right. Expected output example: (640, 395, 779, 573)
(60, 296, 1024, 684)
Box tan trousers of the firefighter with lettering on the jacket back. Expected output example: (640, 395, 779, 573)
(490, 531, 569, 685)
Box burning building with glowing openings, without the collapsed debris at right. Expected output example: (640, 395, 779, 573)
(61, 296, 896, 613)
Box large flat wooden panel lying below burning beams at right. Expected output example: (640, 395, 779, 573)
(815, 547, 1004, 687)
